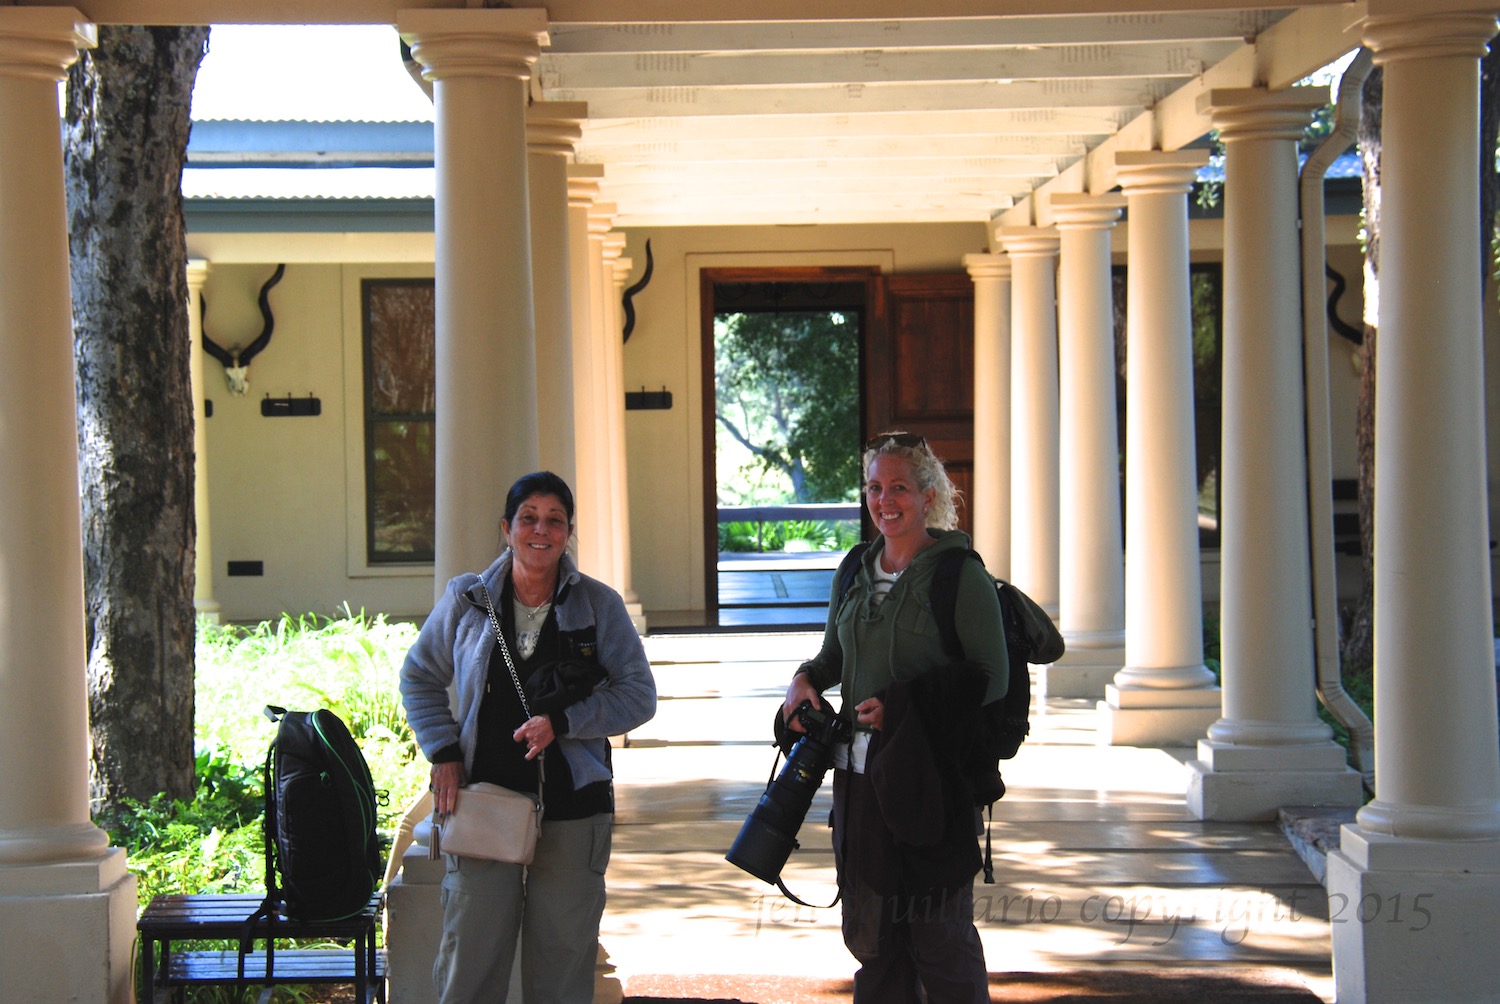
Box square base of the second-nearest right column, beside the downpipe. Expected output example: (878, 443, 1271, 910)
(1187, 740, 1364, 822)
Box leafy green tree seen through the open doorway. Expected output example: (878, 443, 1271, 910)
(714, 311, 860, 504)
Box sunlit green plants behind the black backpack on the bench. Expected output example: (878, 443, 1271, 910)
(108, 608, 428, 906)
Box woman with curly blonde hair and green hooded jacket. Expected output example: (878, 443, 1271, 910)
(782, 432, 1010, 1004)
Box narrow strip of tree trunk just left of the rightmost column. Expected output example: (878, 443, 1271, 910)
(1343, 66, 1385, 681)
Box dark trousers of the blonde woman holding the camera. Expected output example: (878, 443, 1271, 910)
(834, 770, 990, 1004)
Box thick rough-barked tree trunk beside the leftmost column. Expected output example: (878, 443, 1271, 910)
(65, 26, 209, 813)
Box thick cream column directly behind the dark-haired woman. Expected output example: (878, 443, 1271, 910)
(398, 9, 548, 596)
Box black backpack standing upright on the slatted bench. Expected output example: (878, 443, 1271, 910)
(263, 705, 383, 921)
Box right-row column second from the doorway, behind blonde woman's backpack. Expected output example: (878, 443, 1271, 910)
(996, 227, 1059, 620)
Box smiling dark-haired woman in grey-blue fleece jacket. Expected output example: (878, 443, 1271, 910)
(401, 471, 656, 1004)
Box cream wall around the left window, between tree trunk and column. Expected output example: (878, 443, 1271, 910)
(204, 263, 432, 620)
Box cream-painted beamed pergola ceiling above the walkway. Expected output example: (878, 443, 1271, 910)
(38, 0, 1374, 227)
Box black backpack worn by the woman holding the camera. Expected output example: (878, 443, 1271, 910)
(837, 543, 1065, 780)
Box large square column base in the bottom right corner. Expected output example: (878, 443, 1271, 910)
(1328, 824, 1500, 1004)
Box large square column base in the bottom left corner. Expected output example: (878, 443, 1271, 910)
(0, 848, 137, 1004)
